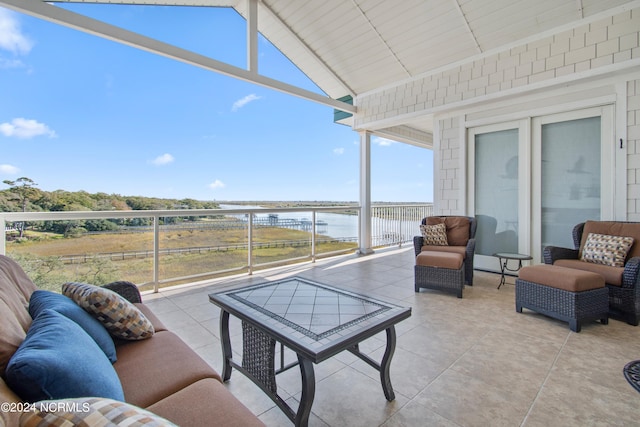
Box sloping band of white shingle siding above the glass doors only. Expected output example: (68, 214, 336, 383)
(355, 8, 640, 125)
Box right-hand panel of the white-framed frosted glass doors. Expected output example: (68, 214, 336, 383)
(532, 107, 614, 259)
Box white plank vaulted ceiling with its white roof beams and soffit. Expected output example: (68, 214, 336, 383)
(0, 0, 640, 147)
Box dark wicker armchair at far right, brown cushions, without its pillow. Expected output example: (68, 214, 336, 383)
(543, 221, 640, 326)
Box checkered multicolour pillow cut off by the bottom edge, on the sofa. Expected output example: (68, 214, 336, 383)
(20, 397, 175, 427)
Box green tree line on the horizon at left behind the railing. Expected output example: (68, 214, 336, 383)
(0, 177, 219, 237)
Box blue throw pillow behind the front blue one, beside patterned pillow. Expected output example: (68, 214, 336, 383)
(29, 290, 118, 363)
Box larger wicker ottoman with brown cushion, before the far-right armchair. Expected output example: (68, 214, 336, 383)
(516, 264, 609, 332)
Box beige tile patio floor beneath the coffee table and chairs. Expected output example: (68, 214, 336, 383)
(144, 247, 640, 427)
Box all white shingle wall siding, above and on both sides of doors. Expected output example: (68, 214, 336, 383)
(354, 8, 640, 217)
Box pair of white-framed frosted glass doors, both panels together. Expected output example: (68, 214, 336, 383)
(467, 106, 614, 271)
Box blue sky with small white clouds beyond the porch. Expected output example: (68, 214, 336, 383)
(0, 4, 433, 202)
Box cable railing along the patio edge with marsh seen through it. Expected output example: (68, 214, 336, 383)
(0, 204, 433, 292)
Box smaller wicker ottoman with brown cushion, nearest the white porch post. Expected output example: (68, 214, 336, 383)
(415, 251, 464, 298)
